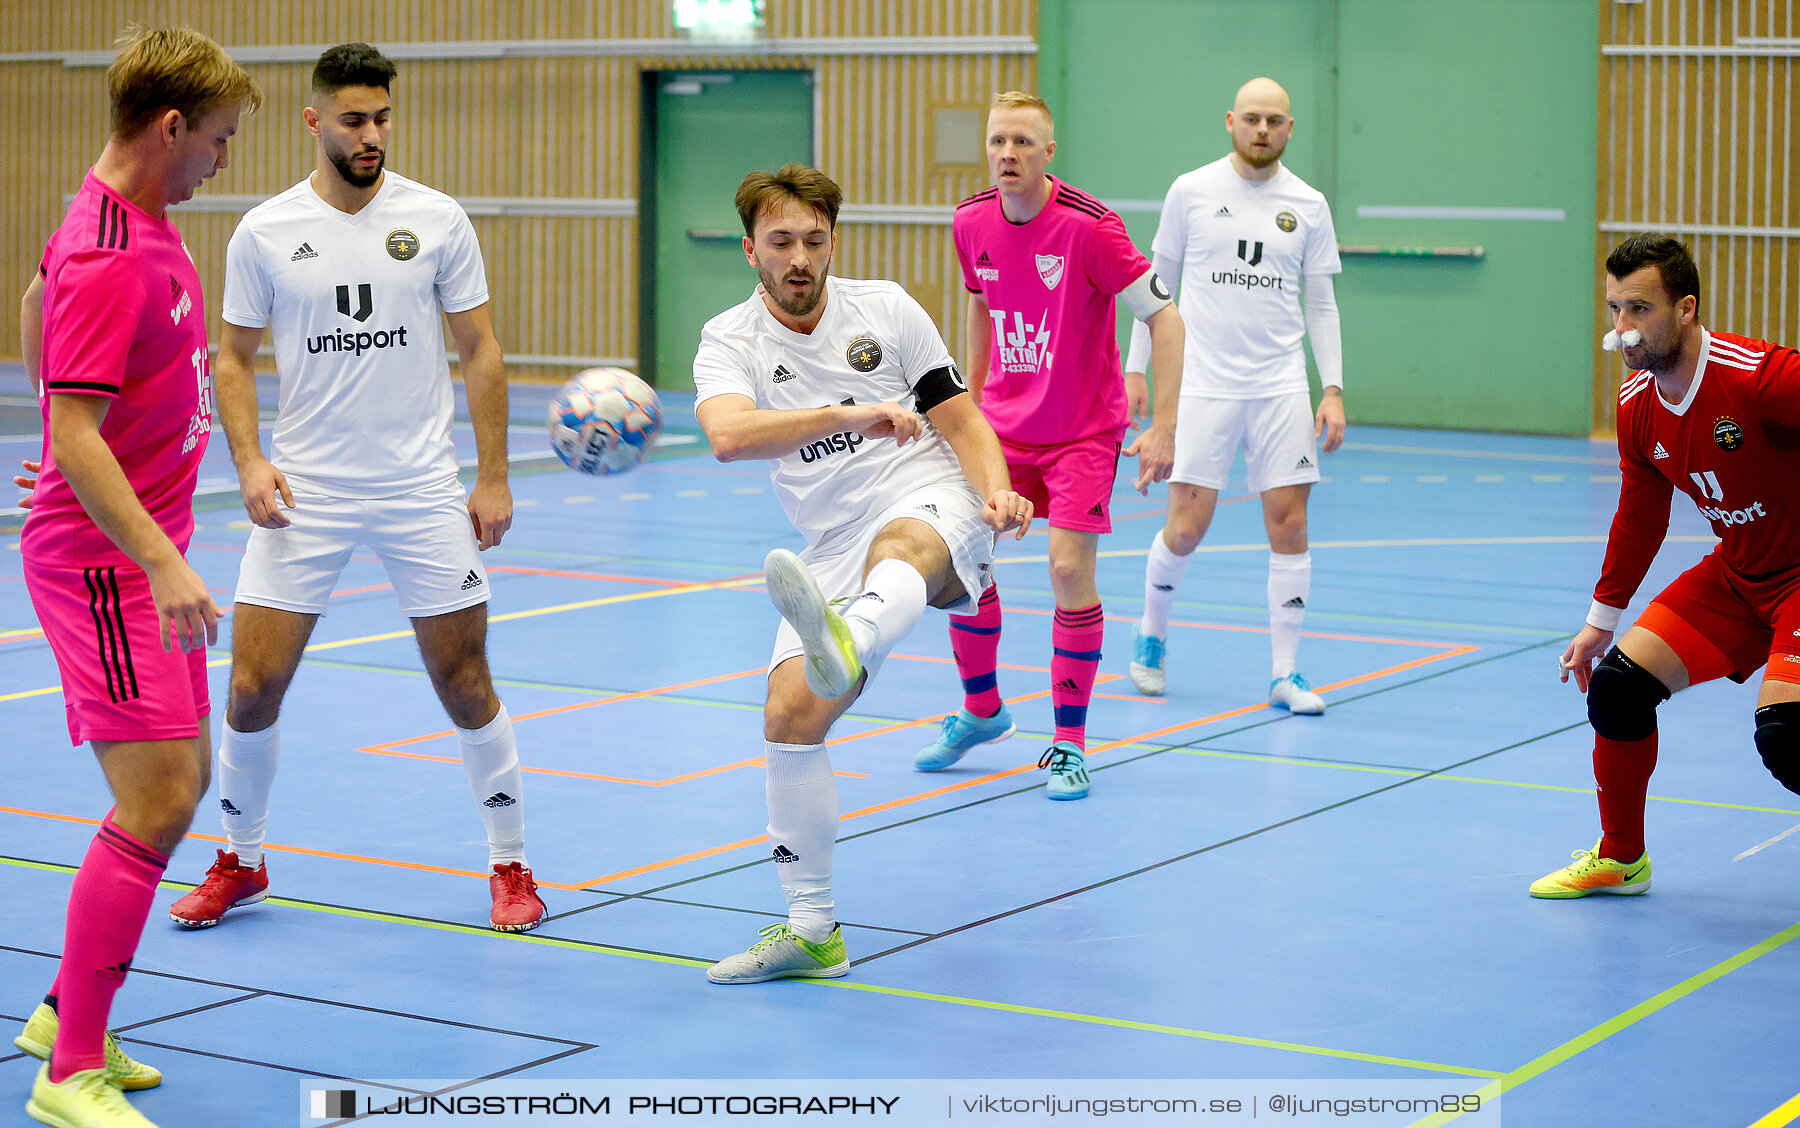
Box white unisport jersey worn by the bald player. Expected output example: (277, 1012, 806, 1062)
(1132, 157, 1343, 399)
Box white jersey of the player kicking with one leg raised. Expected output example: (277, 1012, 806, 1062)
(693, 277, 968, 545)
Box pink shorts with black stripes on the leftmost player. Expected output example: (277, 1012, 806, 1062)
(25, 560, 212, 745)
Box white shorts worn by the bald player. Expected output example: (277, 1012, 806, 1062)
(1168, 392, 1319, 493)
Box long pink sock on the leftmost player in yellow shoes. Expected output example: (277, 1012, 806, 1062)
(50, 813, 169, 1081)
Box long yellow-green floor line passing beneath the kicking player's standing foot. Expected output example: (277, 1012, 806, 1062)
(0, 856, 1490, 1078)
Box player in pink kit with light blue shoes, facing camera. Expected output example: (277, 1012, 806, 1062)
(913, 92, 1184, 799)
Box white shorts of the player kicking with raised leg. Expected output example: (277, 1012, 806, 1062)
(769, 486, 994, 678)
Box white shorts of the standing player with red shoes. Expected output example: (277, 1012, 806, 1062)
(236, 477, 488, 619)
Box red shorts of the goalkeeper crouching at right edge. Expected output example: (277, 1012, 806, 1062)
(1638, 549, 1800, 685)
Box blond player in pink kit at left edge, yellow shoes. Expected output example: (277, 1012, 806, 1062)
(16, 31, 261, 1128)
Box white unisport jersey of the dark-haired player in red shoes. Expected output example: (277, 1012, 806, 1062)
(223, 171, 488, 497)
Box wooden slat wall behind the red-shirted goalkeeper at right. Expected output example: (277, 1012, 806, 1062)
(1593, 0, 1800, 432)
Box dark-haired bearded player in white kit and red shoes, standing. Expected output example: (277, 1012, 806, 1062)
(169, 43, 544, 932)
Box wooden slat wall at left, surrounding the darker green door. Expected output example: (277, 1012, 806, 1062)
(0, 0, 1037, 378)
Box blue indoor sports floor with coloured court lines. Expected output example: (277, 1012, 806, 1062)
(0, 369, 1800, 1128)
